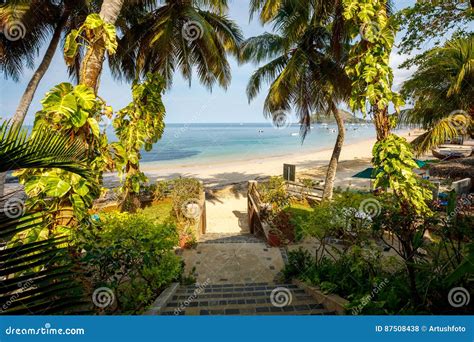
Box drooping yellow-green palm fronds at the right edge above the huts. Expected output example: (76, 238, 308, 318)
(401, 34, 474, 154)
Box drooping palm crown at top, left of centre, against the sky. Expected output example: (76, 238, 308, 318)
(111, 0, 243, 88)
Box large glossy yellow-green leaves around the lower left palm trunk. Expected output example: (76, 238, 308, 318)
(17, 83, 111, 229)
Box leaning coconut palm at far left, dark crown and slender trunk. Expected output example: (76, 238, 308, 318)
(0, 0, 93, 125)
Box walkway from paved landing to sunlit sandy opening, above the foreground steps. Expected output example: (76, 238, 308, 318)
(182, 187, 284, 284)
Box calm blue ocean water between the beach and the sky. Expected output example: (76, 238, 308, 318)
(107, 123, 375, 165)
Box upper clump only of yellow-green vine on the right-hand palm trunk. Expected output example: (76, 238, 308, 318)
(343, 0, 403, 140)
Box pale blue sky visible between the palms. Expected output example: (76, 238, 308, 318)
(0, 0, 415, 124)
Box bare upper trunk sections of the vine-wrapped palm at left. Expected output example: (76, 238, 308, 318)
(79, 0, 124, 93)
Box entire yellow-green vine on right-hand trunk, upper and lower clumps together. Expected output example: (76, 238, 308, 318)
(343, 0, 430, 213)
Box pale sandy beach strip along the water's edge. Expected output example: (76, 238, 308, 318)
(120, 131, 415, 188)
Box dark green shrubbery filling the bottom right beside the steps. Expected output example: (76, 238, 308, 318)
(283, 192, 472, 315)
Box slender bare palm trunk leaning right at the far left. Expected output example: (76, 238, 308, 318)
(0, 12, 69, 197)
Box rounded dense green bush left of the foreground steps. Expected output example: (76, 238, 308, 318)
(77, 213, 182, 314)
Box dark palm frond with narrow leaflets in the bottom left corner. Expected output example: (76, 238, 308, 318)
(0, 213, 88, 315)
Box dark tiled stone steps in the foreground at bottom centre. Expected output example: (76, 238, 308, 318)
(160, 283, 335, 315)
